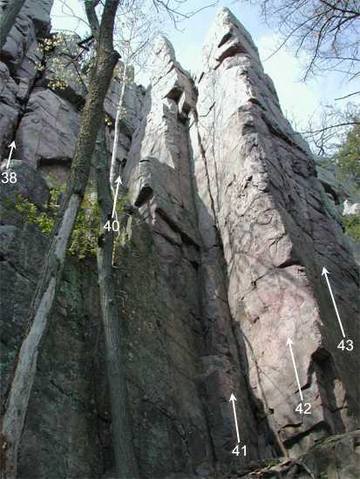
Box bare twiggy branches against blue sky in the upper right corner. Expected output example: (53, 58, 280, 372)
(248, 0, 360, 81)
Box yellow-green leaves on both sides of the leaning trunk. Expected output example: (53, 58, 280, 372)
(15, 188, 100, 259)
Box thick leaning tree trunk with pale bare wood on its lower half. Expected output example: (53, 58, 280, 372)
(1, 0, 119, 479)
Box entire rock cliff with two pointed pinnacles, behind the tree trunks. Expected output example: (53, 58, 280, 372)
(0, 0, 360, 479)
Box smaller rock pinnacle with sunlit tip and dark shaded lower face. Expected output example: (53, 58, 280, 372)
(119, 38, 217, 478)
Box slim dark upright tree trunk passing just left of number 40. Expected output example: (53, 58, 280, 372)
(96, 127, 139, 479)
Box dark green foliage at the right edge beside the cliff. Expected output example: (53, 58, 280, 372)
(336, 124, 360, 186)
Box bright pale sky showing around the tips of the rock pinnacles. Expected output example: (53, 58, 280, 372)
(52, 0, 354, 131)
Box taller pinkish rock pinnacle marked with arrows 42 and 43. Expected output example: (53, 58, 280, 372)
(191, 4, 359, 462)
